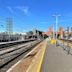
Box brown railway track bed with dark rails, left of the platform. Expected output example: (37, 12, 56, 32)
(0, 41, 40, 72)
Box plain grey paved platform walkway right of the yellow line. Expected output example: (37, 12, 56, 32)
(41, 44, 72, 72)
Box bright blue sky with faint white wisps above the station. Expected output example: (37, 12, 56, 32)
(0, 0, 72, 32)
